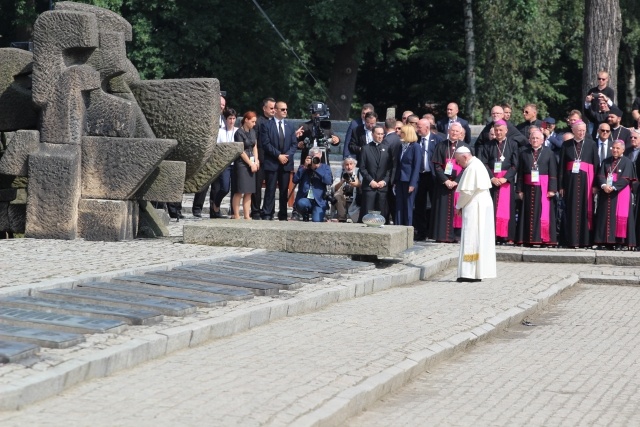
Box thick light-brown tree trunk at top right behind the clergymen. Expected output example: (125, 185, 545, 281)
(582, 0, 622, 103)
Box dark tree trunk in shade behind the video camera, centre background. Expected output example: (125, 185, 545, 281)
(327, 40, 359, 120)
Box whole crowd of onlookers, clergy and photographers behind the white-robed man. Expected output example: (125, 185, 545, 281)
(186, 71, 640, 250)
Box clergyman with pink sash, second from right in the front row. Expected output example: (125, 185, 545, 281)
(558, 121, 599, 248)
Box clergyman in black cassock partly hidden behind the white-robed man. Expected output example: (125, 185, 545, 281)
(430, 123, 471, 243)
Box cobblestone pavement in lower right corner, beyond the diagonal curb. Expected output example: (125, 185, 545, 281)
(348, 285, 640, 427)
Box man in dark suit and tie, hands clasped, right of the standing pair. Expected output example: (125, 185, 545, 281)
(260, 101, 302, 221)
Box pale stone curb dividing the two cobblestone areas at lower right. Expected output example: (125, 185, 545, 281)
(293, 274, 580, 427)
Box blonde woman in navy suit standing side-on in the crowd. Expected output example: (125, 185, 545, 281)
(393, 125, 422, 225)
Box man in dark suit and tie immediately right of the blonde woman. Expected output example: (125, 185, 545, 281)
(413, 119, 442, 241)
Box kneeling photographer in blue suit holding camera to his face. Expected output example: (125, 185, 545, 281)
(293, 147, 333, 222)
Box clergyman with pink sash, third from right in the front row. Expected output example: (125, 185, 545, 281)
(516, 130, 558, 246)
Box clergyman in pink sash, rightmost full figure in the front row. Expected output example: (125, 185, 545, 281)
(593, 139, 636, 250)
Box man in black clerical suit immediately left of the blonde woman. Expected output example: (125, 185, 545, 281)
(358, 125, 393, 222)
